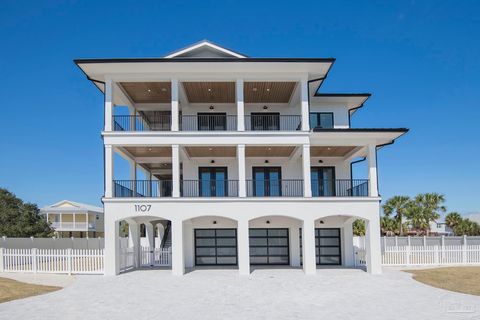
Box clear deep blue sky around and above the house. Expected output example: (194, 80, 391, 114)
(0, 0, 480, 213)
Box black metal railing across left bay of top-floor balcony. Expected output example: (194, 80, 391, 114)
(113, 115, 171, 131)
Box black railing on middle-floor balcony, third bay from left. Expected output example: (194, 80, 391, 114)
(246, 179, 303, 197)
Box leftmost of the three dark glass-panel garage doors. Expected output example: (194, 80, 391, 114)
(195, 229, 237, 266)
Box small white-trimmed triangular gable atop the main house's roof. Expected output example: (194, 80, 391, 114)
(163, 40, 247, 59)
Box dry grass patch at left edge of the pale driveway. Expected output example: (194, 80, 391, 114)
(0, 278, 62, 303)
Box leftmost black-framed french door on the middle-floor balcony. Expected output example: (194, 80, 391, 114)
(198, 167, 228, 197)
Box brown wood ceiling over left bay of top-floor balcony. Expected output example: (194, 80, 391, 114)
(120, 82, 172, 103)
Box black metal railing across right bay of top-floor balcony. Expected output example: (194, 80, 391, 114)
(245, 114, 302, 131)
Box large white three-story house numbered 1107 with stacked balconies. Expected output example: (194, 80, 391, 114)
(75, 41, 408, 275)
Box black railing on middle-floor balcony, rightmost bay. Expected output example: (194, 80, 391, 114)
(311, 179, 368, 197)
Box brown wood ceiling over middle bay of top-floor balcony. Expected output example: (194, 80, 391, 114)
(182, 82, 235, 103)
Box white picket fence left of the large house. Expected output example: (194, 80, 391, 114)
(0, 248, 104, 274)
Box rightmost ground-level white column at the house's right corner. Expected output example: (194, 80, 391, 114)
(365, 215, 382, 274)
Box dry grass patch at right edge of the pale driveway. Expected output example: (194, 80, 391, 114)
(404, 267, 480, 296)
